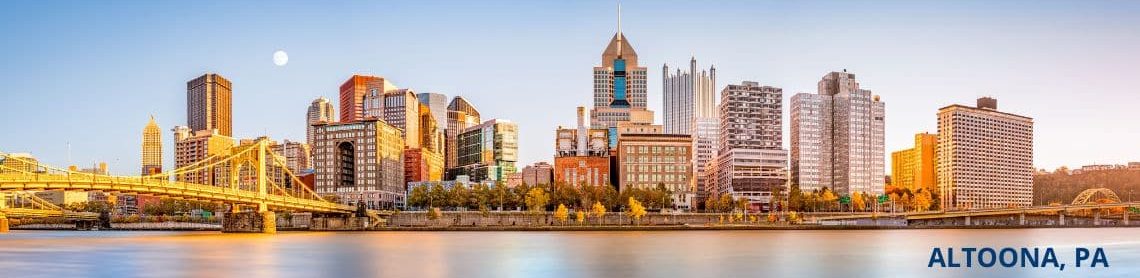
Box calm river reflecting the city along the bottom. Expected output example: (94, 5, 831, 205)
(0, 228, 1140, 278)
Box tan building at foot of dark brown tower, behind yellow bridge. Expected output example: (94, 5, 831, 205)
(174, 126, 235, 185)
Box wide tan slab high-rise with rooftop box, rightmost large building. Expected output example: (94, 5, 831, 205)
(937, 98, 1034, 210)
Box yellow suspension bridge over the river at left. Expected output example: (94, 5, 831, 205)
(0, 139, 356, 232)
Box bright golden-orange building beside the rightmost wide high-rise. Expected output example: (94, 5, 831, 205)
(890, 133, 938, 193)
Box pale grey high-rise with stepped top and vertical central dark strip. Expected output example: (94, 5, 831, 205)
(791, 71, 886, 196)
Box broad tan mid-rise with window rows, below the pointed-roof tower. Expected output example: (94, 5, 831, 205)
(617, 133, 694, 210)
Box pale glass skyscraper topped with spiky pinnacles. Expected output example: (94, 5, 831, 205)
(661, 57, 720, 203)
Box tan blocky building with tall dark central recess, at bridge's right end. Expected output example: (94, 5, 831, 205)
(312, 118, 405, 210)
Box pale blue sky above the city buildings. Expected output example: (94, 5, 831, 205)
(0, 0, 1140, 174)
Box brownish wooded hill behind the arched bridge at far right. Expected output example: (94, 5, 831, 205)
(1033, 170, 1140, 205)
